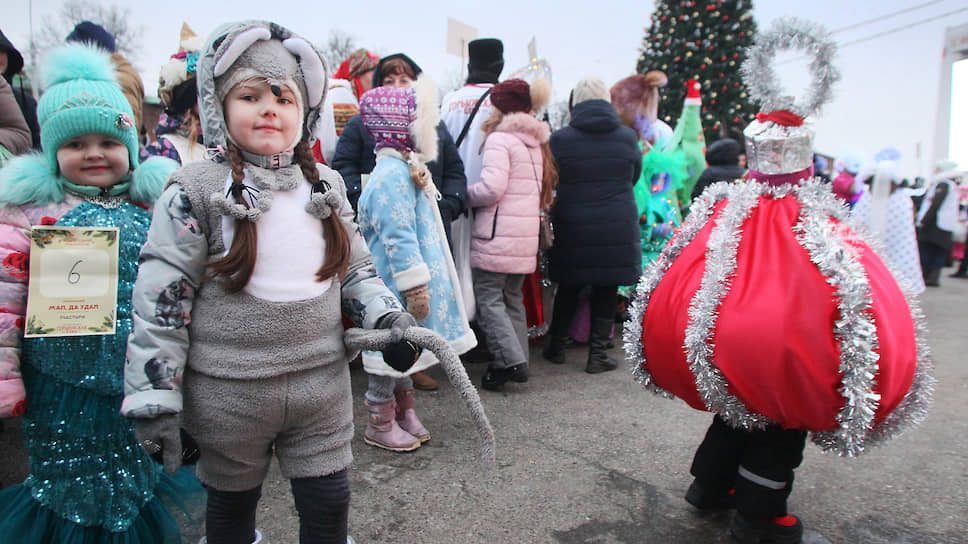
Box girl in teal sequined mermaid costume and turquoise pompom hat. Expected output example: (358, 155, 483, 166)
(0, 45, 195, 544)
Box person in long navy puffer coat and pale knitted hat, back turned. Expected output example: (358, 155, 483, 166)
(544, 78, 642, 374)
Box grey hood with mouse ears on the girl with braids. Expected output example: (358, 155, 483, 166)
(196, 21, 327, 154)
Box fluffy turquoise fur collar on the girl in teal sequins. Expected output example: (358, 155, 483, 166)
(0, 153, 178, 206)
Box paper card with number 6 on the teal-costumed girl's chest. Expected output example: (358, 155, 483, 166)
(24, 225, 118, 338)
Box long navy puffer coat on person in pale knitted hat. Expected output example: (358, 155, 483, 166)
(550, 100, 642, 286)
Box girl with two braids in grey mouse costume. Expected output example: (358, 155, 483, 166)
(122, 21, 416, 544)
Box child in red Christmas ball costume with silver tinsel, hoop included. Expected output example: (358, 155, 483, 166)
(625, 19, 933, 542)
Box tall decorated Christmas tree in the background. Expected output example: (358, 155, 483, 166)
(636, 0, 756, 143)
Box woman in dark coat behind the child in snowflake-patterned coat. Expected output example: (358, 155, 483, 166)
(333, 53, 467, 247)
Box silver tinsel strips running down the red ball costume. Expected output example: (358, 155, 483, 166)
(624, 179, 934, 457)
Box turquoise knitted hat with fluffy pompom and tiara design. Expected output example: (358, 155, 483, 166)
(37, 44, 138, 172)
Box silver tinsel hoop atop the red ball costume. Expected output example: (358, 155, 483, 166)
(741, 17, 840, 117)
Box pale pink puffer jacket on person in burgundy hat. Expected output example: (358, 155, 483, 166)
(467, 113, 549, 274)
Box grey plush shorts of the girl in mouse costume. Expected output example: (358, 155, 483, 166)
(183, 364, 353, 491)
